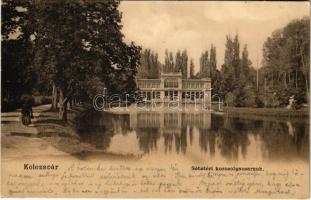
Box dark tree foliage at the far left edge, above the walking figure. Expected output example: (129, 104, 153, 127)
(1, 0, 36, 111)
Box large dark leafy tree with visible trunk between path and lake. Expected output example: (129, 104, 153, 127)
(31, 0, 140, 120)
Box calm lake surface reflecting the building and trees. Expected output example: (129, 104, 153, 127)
(78, 112, 309, 161)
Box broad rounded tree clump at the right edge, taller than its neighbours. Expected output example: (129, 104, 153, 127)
(261, 17, 310, 105)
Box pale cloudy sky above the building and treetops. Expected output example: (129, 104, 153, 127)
(119, 1, 310, 71)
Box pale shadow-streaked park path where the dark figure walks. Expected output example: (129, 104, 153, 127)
(1, 105, 68, 160)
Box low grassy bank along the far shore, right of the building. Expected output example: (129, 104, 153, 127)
(223, 107, 309, 118)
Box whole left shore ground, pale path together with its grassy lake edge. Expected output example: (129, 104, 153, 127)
(1, 105, 142, 160)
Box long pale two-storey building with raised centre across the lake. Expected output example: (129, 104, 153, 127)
(136, 72, 212, 106)
